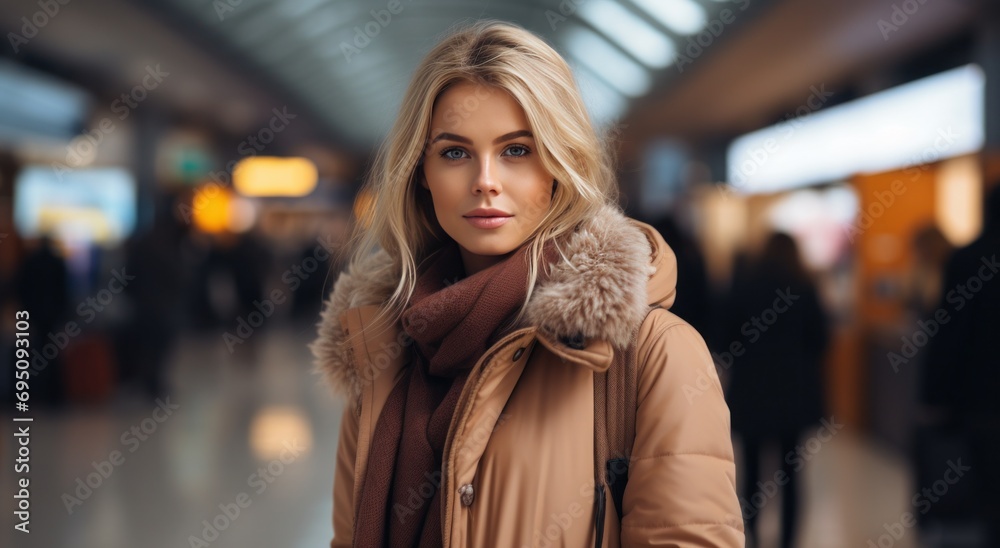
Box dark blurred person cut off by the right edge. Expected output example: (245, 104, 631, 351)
(922, 182, 1000, 547)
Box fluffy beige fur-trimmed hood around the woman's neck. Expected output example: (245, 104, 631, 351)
(310, 205, 677, 393)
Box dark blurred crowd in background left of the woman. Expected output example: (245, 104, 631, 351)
(0, 191, 340, 407)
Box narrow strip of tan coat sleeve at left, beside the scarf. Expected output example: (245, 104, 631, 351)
(330, 400, 359, 548)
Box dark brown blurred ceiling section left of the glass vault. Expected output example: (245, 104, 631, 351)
(0, 0, 306, 142)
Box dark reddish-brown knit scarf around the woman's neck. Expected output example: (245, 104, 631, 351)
(354, 238, 554, 548)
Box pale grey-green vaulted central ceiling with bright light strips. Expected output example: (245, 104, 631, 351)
(152, 0, 748, 148)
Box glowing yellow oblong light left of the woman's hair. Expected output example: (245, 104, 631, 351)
(233, 156, 318, 197)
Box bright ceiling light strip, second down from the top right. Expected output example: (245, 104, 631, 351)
(579, 0, 676, 69)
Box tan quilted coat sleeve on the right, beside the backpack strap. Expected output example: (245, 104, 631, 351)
(621, 310, 744, 548)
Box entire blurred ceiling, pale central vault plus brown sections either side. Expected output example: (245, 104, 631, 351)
(0, 0, 976, 162)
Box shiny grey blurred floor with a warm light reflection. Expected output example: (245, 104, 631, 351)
(0, 326, 948, 548)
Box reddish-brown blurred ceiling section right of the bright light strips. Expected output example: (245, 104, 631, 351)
(623, 0, 978, 154)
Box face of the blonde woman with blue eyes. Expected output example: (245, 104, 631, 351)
(421, 83, 553, 276)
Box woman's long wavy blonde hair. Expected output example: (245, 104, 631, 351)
(346, 21, 619, 325)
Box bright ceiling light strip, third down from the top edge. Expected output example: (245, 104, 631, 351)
(566, 26, 651, 97)
